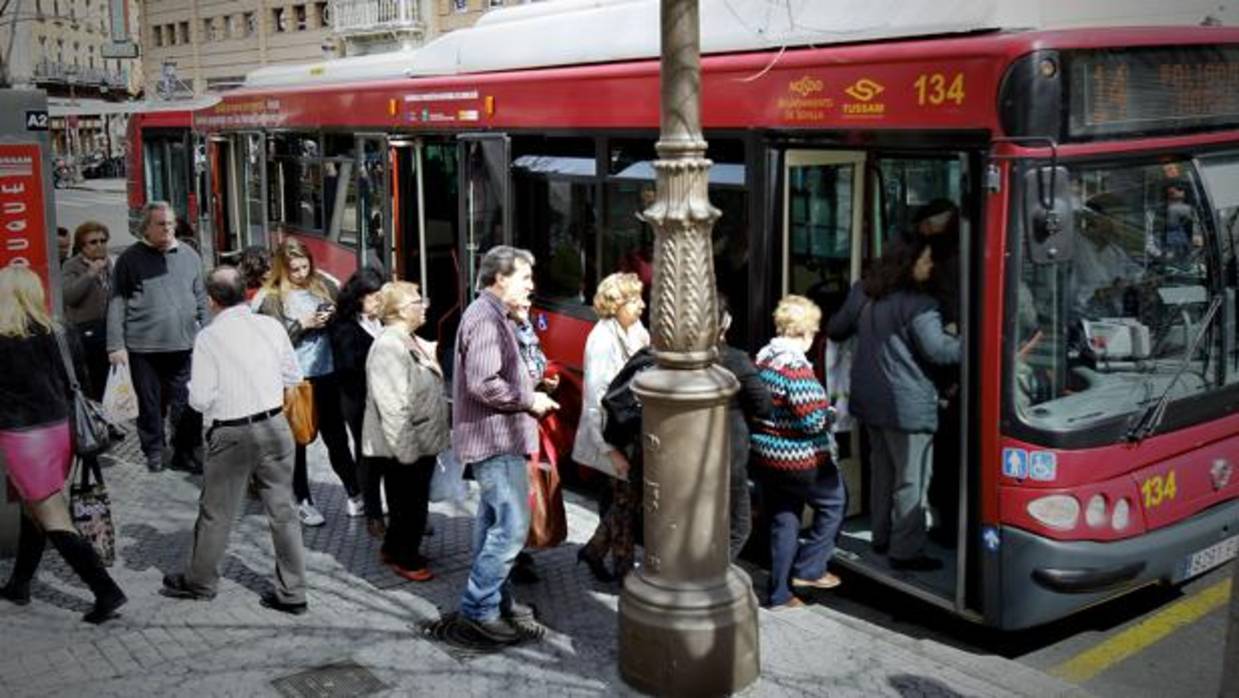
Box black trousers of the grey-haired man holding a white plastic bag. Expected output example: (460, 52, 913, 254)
(129, 351, 202, 460)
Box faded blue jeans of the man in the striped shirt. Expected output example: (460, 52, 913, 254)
(461, 455, 529, 621)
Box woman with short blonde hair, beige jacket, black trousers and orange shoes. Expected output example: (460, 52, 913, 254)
(362, 281, 451, 581)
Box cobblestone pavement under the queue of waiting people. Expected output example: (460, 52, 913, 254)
(0, 436, 1073, 698)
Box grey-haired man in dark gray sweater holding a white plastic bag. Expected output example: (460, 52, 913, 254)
(108, 201, 207, 472)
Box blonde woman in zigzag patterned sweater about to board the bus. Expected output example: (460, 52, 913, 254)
(752, 295, 846, 609)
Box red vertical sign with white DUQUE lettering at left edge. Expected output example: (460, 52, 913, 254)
(0, 143, 52, 300)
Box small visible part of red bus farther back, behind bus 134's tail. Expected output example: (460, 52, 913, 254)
(125, 97, 218, 250)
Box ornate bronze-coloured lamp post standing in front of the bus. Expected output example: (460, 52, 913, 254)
(620, 0, 760, 696)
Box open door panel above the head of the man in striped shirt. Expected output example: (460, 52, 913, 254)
(460, 134, 512, 298)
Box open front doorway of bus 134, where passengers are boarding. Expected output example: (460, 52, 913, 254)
(779, 150, 976, 614)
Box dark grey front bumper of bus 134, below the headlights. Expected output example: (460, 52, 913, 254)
(996, 500, 1239, 630)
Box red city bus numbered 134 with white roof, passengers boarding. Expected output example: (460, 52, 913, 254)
(185, 6, 1239, 629)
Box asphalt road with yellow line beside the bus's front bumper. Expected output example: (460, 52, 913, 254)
(818, 557, 1233, 698)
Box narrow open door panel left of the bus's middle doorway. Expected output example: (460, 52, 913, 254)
(354, 134, 394, 272)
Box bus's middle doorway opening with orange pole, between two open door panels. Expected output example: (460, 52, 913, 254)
(390, 136, 468, 359)
